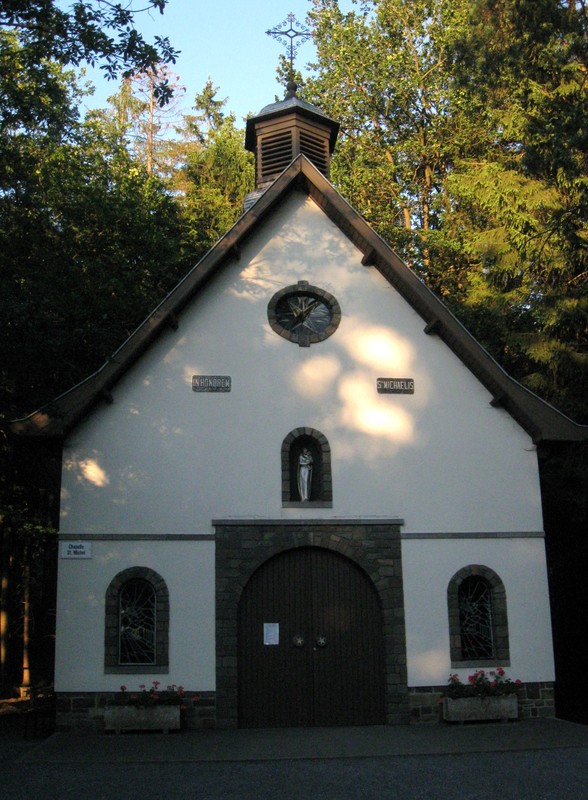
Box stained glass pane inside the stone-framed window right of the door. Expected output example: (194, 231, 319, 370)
(458, 575, 494, 660)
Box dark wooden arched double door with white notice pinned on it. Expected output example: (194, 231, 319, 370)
(239, 547, 385, 727)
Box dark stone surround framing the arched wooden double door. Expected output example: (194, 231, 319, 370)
(213, 519, 410, 728)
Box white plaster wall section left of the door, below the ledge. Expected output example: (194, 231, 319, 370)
(55, 541, 215, 692)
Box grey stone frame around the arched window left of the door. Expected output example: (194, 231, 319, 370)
(104, 567, 169, 675)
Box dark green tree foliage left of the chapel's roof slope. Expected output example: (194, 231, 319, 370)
(0, 113, 187, 410)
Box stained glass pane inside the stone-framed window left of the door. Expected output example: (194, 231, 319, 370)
(119, 578, 156, 664)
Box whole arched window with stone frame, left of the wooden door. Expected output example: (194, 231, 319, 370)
(104, 567, 169, 674)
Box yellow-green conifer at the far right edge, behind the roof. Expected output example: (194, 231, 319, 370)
(452, 0, 588, 421)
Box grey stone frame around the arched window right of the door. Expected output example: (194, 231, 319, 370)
(447, 564, 510, 669)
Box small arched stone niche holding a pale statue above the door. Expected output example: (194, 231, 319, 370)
(282, 428, 333, 507)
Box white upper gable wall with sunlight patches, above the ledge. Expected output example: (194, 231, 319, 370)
(61, 194, 542, 536)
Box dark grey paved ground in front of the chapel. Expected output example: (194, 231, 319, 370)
(0, 720, 588, 800)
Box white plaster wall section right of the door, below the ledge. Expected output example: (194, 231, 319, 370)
(402, 538, 554, 686)
